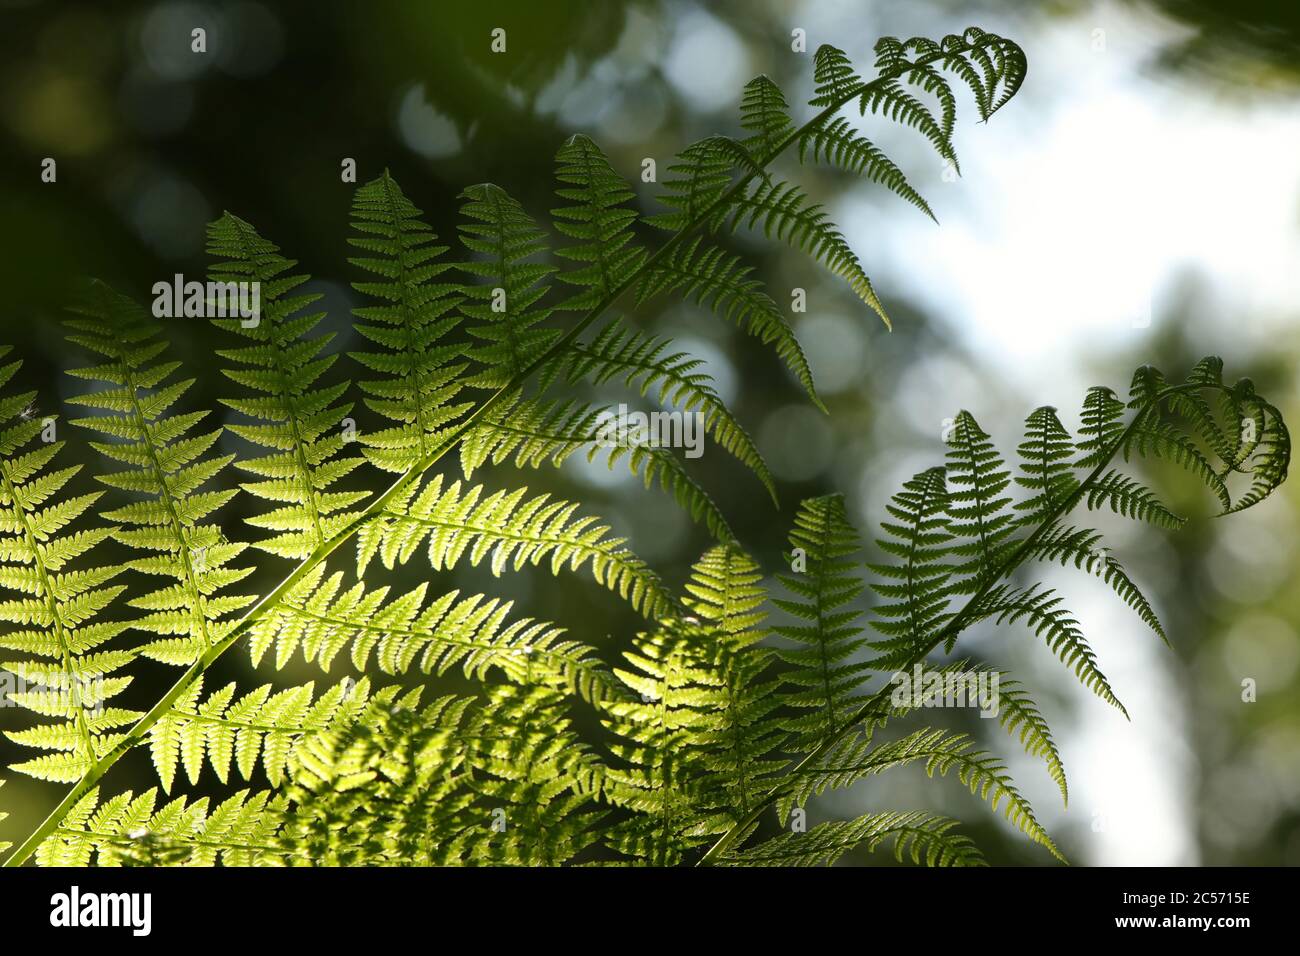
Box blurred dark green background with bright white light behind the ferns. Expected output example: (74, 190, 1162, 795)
(0, 0, 1300, 865)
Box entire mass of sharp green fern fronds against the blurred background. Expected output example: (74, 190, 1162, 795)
(0, 29, 1290, 865)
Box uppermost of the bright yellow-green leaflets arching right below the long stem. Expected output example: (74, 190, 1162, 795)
(358, 475, 670, 618)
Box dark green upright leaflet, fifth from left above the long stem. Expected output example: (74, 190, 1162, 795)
(460, 183, 560, 389)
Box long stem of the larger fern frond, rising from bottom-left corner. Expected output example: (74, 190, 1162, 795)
(4, 44, 954, 866)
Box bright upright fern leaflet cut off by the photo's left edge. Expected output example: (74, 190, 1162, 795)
(0, 346, 139, 783)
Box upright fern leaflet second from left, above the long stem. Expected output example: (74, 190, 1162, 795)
(68, 282, 255, 666)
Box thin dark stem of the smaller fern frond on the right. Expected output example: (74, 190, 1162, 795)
(696, 384, 1211, 866)
